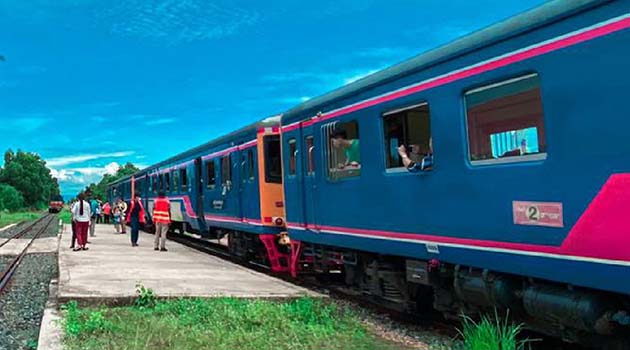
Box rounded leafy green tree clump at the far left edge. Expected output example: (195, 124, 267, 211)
(0, 150, 59, 208)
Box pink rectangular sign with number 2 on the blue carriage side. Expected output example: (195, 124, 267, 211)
(512, 201, 564, 227)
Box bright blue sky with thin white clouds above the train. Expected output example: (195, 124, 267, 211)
(0, 0, 545, 194)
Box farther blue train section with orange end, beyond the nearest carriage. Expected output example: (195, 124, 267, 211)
(110, 116, 288, 272)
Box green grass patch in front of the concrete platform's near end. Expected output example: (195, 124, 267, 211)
(64, 298, 410, 350)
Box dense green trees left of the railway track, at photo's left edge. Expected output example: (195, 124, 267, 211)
(0, 149, 60, 211)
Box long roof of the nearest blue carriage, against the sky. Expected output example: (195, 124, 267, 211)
(282, 0, 613, 124)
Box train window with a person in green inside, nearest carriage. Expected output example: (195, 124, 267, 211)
(323, 120, 361, 180)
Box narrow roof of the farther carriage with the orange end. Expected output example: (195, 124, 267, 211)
(109, 114, 281, 185)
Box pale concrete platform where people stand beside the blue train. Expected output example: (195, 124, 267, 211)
(58, 225, 317, 304)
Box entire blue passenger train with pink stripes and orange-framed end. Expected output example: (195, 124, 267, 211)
(110, 0, 630, 349)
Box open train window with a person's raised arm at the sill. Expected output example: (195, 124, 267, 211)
(383, 103, 433, 169)
